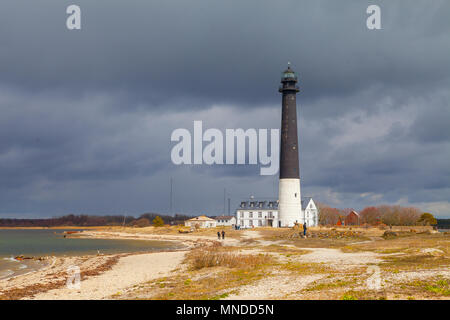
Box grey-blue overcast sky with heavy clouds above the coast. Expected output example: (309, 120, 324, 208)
(0, 0, 450, 217)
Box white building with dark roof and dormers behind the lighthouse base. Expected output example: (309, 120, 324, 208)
(236, 197, 319, 228)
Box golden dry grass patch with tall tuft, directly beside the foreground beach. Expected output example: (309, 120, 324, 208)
(118, 245, 276, 300)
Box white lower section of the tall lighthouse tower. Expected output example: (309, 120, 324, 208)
(278, 179, 302, 227)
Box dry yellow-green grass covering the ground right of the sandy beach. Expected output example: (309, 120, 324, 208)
(111, 228, 450, 300)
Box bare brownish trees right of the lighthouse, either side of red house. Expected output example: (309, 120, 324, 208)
(318, 203, 437, 226)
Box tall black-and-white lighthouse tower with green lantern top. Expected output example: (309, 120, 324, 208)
(278, 63, 304, 227)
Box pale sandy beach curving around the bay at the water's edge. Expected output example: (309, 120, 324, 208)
(0, 230, 224, 300)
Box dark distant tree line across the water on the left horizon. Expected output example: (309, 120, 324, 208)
(0, 213, 192, 227)
